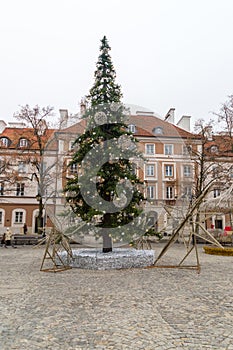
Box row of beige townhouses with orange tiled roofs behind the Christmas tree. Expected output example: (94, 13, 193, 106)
(0, 105, 233, 238)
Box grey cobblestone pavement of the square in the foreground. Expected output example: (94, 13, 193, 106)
(0, 244, 233, 350)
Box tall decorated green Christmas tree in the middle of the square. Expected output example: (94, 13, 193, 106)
(65, 36, 147, 252)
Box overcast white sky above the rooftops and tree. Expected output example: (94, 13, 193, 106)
(0, 0, 233, 129)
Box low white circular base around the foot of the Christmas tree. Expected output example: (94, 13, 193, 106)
(60, 248, 155, 270)
